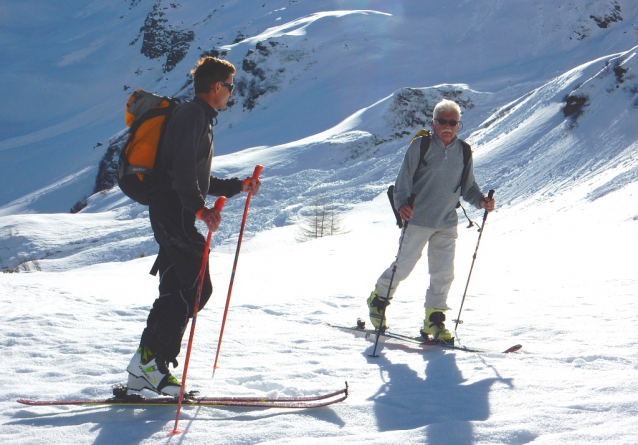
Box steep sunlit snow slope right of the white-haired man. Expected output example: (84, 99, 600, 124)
(470, 47, 638, 202)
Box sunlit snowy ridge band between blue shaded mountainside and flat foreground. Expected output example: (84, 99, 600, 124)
(0, 42, 638, 270)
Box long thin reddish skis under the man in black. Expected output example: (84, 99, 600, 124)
(17, 382, 348, 409)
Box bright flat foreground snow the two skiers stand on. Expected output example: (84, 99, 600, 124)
(0, 185, 638, 444)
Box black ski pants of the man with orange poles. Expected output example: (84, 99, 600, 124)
(142, 192, 213, 366)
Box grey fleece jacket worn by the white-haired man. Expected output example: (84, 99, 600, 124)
(394, 134, 484, 229)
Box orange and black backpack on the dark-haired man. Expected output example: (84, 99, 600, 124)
(117, 90, 180, 205)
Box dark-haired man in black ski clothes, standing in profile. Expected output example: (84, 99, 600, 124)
(127, 57, 261, 396)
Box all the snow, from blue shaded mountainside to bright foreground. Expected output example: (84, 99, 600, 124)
(0, 0, 638, 445)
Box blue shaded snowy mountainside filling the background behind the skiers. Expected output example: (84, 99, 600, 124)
(0, 0, 638, 214)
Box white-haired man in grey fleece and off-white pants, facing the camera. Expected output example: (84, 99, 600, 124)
(367, 99, 495, 341)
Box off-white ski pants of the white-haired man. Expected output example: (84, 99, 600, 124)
(377, 224, 457, 310)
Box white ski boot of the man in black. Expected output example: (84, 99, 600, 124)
(126, 345, 182, 397)
